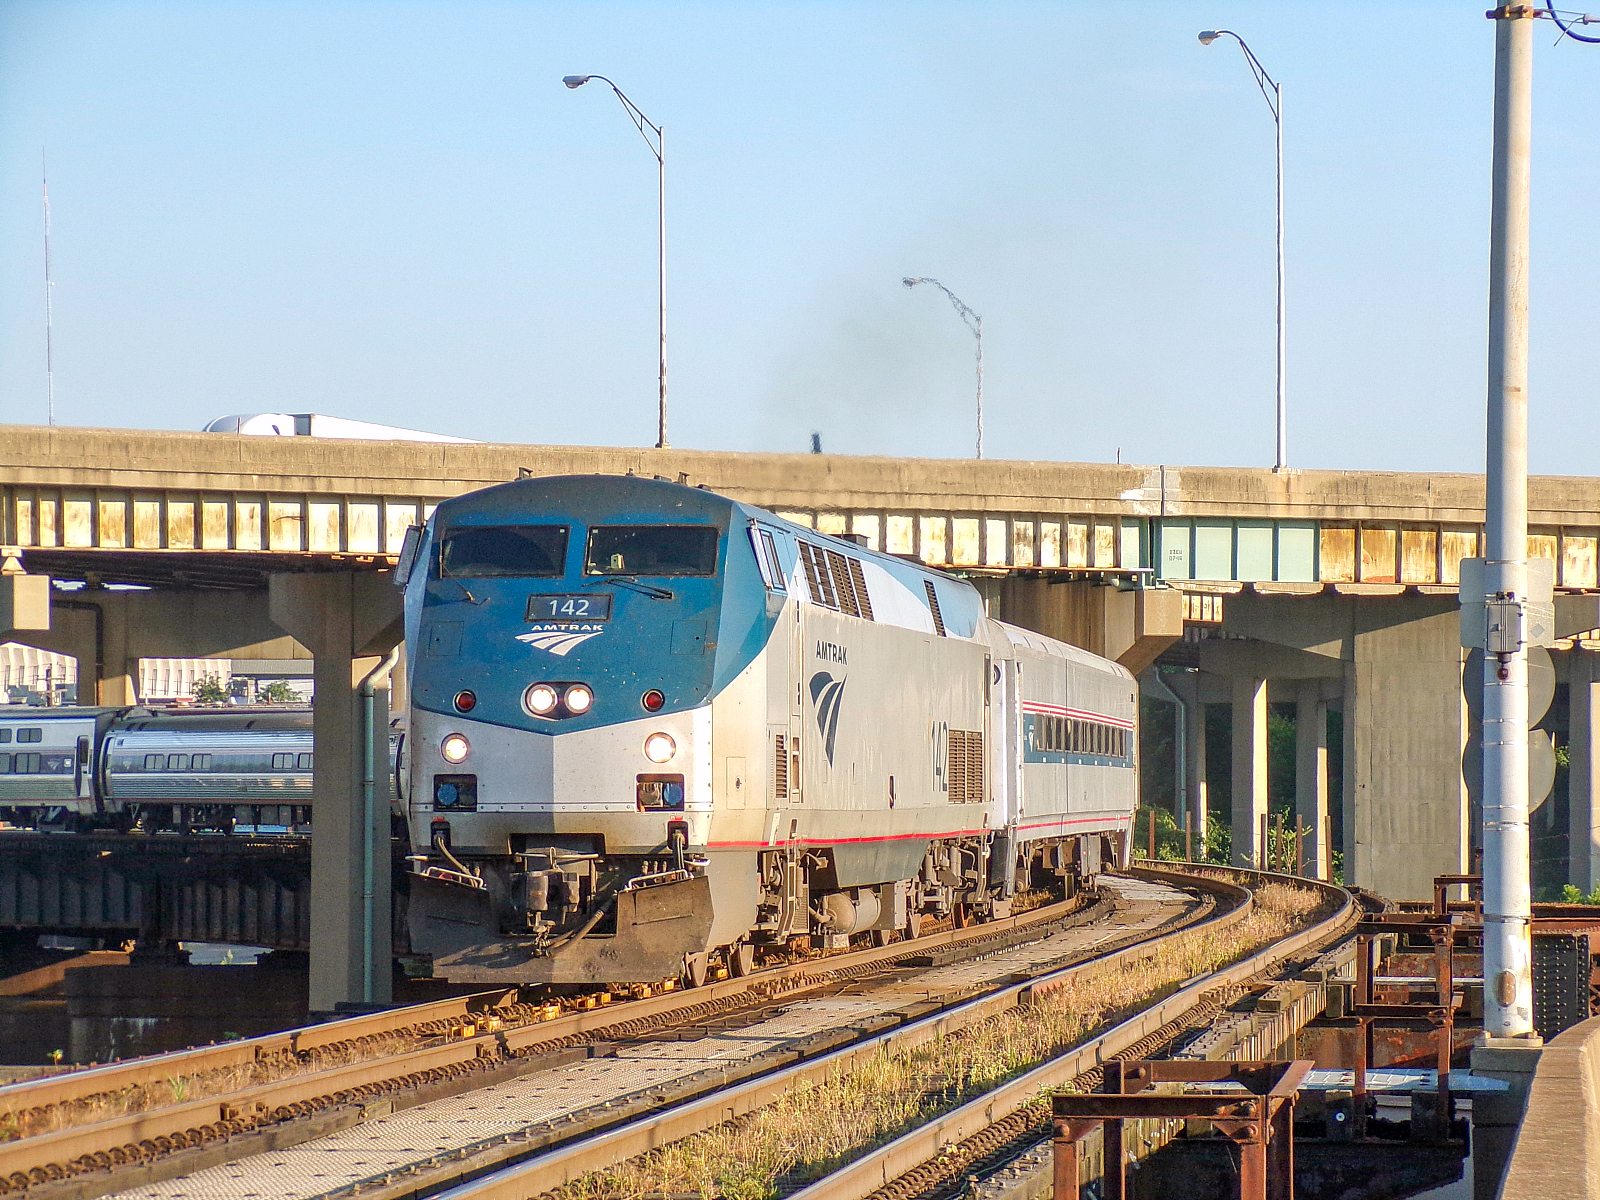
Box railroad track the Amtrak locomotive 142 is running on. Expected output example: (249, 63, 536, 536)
(0, 876, 1203, 1200)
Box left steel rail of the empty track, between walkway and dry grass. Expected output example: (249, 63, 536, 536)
(412, 872, 1259, 1200)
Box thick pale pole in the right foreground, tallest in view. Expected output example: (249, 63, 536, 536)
(1483, 5, 1534, 1037)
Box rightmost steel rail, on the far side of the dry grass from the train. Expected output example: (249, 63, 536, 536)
(789, 867, 1358, 1200)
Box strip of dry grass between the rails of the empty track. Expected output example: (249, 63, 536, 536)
(554, 883, 1320, 1200)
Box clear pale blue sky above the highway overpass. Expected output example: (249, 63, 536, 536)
(0, 0, 1600, 475)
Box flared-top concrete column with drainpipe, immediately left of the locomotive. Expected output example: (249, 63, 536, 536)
(270, 573, 403, 1013)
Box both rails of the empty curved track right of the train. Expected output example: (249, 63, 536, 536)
(406, 870, 1357, 1200)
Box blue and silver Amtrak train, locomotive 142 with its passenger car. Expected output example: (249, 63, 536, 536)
(406, 475, 1138, 984)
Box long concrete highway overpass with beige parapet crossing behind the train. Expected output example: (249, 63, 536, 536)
(0, 427, 1600, 960)
